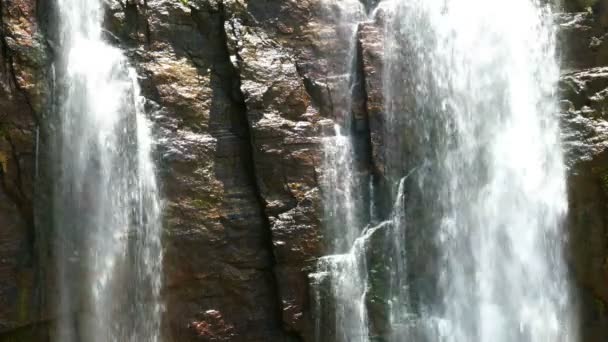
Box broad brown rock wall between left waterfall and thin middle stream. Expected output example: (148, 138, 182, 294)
(108, 0, 340, 341)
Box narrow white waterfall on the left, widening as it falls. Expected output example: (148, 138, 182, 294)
(53, 0, 162, 342)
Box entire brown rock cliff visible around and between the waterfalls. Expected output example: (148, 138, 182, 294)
(0, 0, 608, 342)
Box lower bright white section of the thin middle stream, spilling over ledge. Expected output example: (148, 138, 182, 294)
(311, 127, 368, 341)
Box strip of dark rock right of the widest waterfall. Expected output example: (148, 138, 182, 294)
(558, 7, 608, 341)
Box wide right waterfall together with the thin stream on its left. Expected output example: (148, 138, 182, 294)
(311, 0, 578, 342)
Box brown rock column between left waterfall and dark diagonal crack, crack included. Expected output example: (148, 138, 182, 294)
(125, 0, 294, 341)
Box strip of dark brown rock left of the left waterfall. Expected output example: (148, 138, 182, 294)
(0, 0, 48, 340)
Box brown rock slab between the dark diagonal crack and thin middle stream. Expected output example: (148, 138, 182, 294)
(226, 17, 321, 338)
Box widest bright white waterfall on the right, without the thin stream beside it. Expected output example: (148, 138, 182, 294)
(381, 0, 577, 342)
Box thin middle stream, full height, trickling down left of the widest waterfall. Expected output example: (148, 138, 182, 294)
(311, 0, 369, 342)
